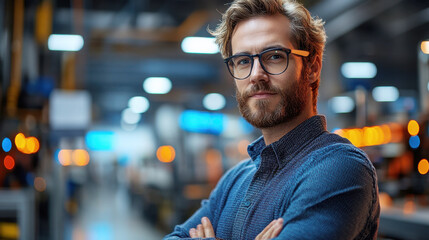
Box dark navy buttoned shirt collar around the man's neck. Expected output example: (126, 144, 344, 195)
(247, 115, 326, 168)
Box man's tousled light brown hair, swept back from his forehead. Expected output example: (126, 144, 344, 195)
(210, 0, 326, 111)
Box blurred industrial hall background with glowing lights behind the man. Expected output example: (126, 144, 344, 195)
(0, 0, 429, 240)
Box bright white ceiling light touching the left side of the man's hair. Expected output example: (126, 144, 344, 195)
(182, 37, 219, 54)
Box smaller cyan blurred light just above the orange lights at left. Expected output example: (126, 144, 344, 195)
(85, 131, 115, 151)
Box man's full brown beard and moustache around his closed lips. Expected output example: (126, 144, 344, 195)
(235, 79, 309, 129)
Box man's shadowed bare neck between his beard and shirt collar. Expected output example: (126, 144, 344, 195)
(261, 112, 316, 146)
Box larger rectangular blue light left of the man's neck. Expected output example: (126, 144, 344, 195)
(179, 110, 226, 135)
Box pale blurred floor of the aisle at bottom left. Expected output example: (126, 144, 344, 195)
(65, 186, 164, 240)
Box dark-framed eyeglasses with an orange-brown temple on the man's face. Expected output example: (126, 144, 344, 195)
(224, 48, 310, 80)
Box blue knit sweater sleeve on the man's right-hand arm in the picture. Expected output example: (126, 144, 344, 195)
(278, 145, 380, 239)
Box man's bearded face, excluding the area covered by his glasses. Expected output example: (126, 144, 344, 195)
(231, 14, 310, 128)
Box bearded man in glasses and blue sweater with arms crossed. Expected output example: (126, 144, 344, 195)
(165, 0, 380, 240)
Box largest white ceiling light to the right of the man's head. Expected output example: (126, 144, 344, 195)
(341, 62, 377, 78)
